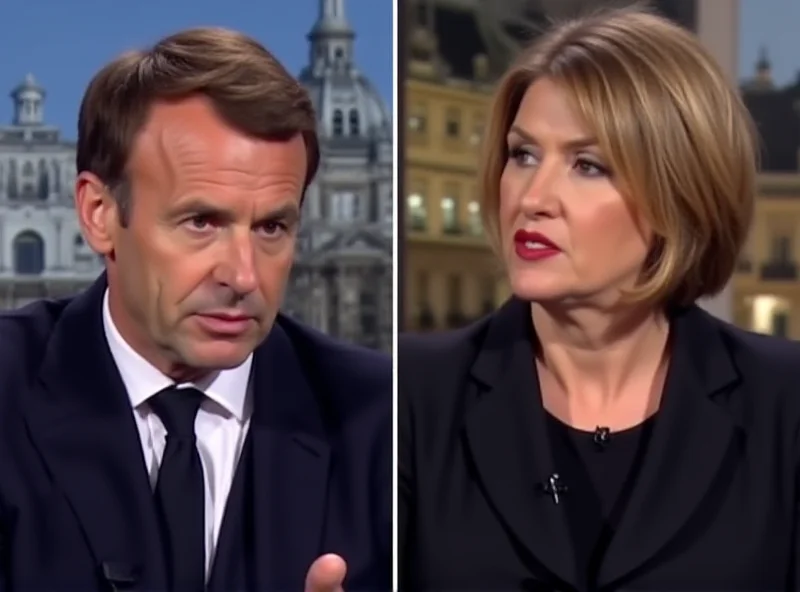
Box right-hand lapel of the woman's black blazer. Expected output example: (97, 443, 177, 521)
(599, 307, 743, 587)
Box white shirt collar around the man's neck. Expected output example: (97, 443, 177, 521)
(103, 289, 253, 421)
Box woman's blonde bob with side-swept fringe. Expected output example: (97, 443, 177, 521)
(481, 8, 758, 306)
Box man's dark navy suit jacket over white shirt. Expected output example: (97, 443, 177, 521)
(0, 278, 392, 592)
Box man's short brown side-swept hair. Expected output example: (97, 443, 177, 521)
(76, 27, 319, 225)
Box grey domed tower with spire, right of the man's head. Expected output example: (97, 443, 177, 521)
(284, 0, 394, 351)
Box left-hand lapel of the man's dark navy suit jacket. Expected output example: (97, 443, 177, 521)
(26, 277, 164, 589)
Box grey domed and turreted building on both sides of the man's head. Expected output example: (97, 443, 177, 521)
(0, 0, 394, 350)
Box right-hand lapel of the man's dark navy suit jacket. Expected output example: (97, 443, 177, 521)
(250, 322, 330, 590)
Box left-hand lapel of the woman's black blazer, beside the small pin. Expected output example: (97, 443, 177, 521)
(466, 299, 577, 586)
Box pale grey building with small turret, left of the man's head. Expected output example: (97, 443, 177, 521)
(0, 76, 103, 308)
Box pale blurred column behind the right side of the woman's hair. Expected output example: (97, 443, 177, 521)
(696, 0, 739, 321)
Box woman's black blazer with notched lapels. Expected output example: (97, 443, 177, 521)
(397, 299, 800, 592)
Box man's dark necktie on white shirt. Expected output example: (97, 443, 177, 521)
(150, 387, 205, 592)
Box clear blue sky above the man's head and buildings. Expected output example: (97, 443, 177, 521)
(0, 0, 392, 139)
